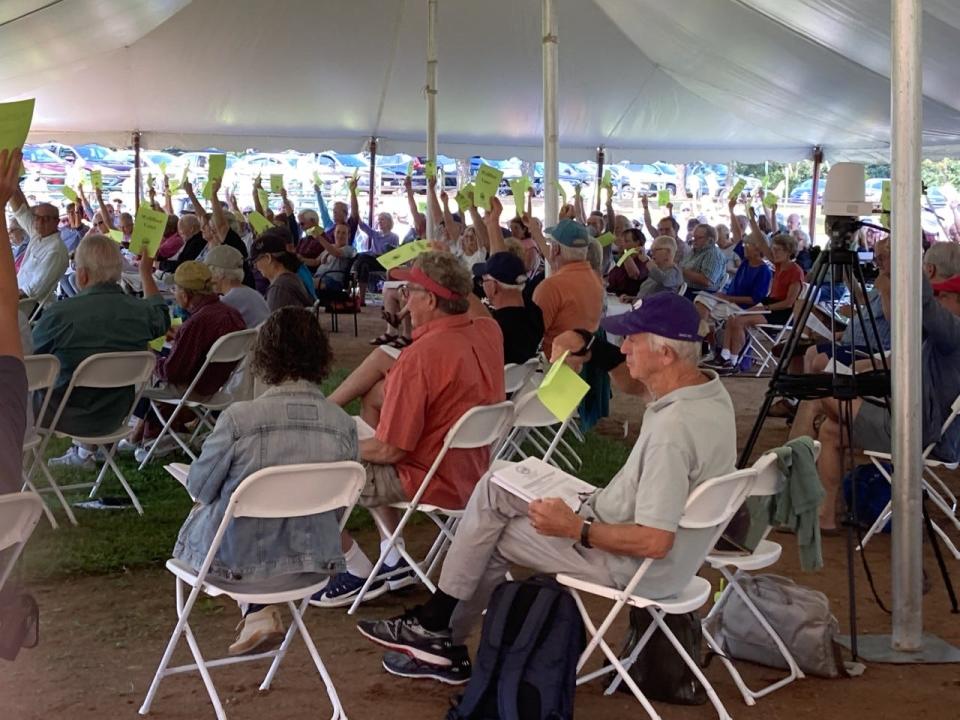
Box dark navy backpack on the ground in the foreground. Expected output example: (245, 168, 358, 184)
(447, 575, 584, 720)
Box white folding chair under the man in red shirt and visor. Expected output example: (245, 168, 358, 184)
(347, 400, 514, 615)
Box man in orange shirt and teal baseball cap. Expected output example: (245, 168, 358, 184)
(533, 220, 603, 357)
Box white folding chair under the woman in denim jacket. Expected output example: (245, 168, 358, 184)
(140, 462, 366, 720)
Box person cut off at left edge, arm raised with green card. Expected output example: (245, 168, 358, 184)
(0, 148, 27, 494)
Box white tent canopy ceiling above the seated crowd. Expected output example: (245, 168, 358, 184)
(7, 0, 960, 162)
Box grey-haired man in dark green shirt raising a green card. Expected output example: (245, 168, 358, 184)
(33, 239, 170, 469)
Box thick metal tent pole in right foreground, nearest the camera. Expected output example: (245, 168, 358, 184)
(890, 0, 923, 652)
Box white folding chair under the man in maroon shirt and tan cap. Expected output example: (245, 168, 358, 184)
(139, 329, 257, 470)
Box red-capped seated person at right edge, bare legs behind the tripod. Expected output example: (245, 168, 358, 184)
(790, 275, 960, 530)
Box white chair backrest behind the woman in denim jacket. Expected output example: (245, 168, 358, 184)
(224, 461, 367, 520)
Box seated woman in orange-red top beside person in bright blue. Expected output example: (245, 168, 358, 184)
(709, 233, 803, 374)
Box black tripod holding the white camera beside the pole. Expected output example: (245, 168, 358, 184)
(737, 217, 890, 659)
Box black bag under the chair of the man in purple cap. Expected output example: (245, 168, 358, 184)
(617, 608, 707, 705)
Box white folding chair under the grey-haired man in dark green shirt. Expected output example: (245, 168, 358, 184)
(37, 350, 156, 515)
